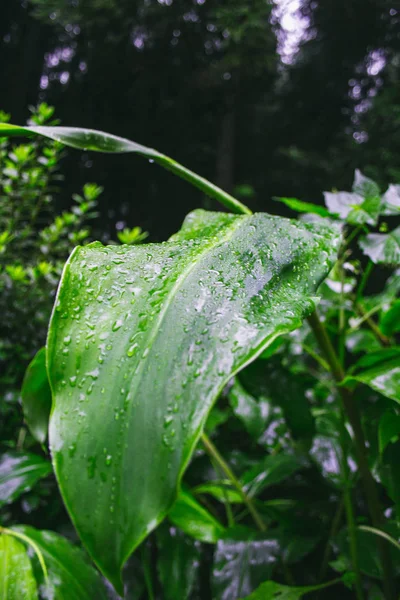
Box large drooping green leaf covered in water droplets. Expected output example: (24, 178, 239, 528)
(47, 210, 339, 589)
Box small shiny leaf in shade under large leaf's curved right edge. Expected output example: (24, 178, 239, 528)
(228, 380, 268, 439)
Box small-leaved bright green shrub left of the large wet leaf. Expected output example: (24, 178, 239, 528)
(0, 104, 102, 432)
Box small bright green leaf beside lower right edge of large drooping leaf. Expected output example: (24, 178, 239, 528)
(168, 490, 225, 544)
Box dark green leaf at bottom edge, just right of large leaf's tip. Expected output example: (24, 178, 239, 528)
(157, 526, 200, 600)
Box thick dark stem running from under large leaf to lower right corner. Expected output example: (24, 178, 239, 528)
(308, 311, 395, 600)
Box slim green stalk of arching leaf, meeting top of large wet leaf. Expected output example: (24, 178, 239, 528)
(154, 154, 252, 215)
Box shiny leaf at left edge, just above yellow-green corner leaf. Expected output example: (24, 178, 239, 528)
(0, 452, 52, 506)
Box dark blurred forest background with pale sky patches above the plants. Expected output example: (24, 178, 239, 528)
(0, 0, 400, 240)
